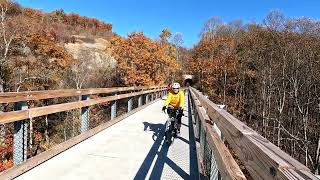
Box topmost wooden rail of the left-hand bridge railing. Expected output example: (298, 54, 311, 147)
(0, 86, 164, 103)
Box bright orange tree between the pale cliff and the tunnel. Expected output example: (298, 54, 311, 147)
(112, 32, 179, 86)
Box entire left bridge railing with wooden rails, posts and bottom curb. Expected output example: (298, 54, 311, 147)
(0, 86, 166, 179)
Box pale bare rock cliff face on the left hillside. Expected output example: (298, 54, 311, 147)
(64, 36, 117, 89)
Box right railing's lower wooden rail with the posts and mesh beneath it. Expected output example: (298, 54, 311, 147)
(189, 88, 246, 179)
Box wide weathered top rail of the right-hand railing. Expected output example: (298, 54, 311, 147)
(191, 88, 317, 180)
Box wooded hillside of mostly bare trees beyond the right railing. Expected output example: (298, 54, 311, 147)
(185, 11, 320, 173)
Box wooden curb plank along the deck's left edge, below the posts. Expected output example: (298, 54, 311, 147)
(0, 99, 159, 179)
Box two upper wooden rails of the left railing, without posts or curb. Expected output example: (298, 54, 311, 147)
(0, 87, 163, 124)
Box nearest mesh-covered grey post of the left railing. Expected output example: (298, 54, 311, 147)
(13, 101, 28, 166)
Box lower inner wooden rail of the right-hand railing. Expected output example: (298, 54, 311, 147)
(190, 89, 246, 180)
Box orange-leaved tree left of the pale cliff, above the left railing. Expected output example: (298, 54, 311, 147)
(10, 34, 74, 91)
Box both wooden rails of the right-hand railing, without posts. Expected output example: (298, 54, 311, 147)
(190, 88, 317, 179)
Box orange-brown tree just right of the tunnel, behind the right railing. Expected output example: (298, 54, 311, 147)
(187, 38, 238, 106)
